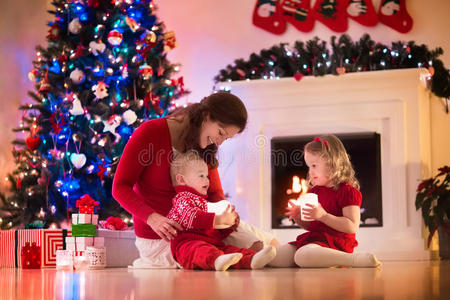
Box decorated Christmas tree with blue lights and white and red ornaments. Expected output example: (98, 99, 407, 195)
(0, 0, 186, 228)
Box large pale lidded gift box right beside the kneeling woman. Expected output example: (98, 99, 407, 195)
(97, 229, 139, 268)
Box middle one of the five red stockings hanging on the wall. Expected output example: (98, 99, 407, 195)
(311, 0, 348, 32)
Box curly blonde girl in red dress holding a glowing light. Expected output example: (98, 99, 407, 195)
(270, 135, 381, 267)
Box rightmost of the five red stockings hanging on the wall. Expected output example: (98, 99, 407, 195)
(378, 0, 413, 33)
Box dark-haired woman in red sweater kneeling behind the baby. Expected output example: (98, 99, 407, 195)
(112, 92, 274, 268)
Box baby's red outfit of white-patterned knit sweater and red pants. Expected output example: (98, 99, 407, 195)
(167, 186, 255, 270)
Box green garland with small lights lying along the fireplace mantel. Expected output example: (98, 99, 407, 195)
(214, 34, 450, 105)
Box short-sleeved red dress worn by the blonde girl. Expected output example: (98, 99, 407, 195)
(289, 183, 361, 253)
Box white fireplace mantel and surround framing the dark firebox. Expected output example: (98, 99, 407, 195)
(219, 69, 431, 260)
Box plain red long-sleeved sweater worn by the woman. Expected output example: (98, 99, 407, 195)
(112, 118, 225, 239)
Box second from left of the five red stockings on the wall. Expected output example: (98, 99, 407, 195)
(280, 0, 314, 32)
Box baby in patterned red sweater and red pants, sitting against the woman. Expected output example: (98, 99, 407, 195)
(167, 150, 276, 271)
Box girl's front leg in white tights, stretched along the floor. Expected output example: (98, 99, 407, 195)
(294, 244, 381, 268)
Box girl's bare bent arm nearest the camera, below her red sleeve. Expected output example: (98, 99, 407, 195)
(303, 203, 361, 233)
